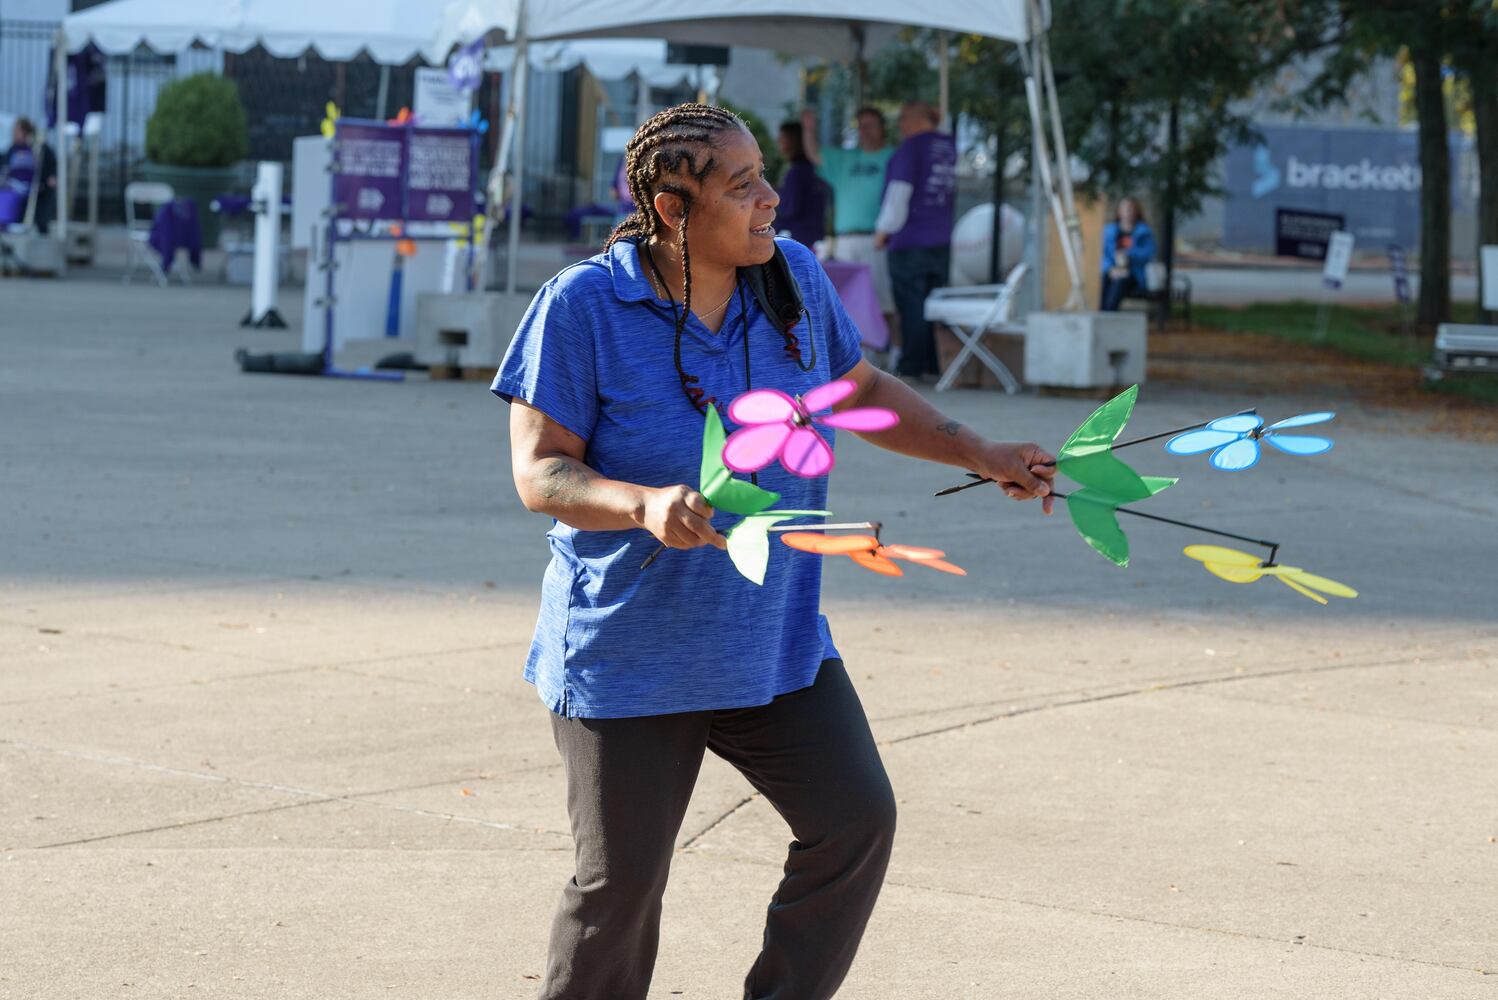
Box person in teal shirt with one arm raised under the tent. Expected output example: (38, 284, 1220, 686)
(801, 106, 900, 360)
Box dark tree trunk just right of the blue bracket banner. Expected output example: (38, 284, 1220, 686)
(1410, 39, 1452, 334)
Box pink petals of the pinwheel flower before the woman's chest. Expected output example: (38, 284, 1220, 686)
(724, 379, 900, 479)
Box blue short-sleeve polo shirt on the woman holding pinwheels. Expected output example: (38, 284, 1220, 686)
(491, 240, 861, 719)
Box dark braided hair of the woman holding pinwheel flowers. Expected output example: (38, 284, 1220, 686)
(604, 103, 801, 413)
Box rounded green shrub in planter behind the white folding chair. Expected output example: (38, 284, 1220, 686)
(145, 73, 249, 166)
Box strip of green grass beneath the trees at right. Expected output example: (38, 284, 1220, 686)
(1192, 301, 1498, 404)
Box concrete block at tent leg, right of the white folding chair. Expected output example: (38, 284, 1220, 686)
(1025, 313, 1149, 389)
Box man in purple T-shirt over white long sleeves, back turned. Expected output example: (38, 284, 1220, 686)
(873, 100, 957, 379)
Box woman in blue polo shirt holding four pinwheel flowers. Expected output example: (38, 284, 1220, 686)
(493, 105, 1052, 1000)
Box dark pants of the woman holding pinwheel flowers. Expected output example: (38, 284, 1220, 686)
(541, 660, 894, 1000)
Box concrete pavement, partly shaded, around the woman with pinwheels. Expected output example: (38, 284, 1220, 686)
(0, 277, 1498, 1000)
